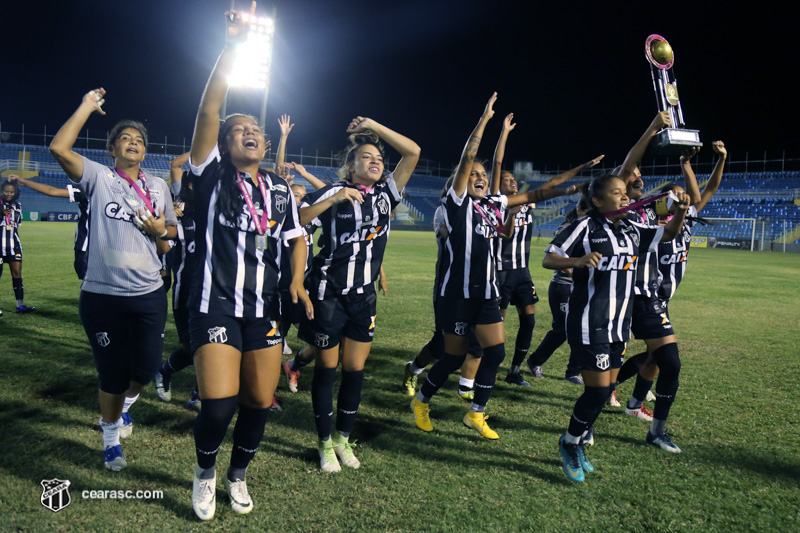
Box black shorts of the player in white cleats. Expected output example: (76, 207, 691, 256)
(189, 297, 283, 353)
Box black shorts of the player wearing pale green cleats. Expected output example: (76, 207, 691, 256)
(297, 292, 377, 350)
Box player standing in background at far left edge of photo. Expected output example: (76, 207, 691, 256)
(0, 180, 36, 316)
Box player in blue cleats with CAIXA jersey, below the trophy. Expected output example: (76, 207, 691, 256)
(542, 173, 689, 482)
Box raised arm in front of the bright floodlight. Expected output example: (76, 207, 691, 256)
(190, 2, 256, 165)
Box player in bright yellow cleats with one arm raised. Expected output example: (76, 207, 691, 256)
(411, 93, 575, 439)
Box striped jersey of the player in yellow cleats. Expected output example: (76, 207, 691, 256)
(437, 187, 508, 300)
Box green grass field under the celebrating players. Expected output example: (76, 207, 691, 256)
(0, 223, 800, 532)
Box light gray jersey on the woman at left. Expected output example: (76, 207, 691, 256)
(78, 157, 178, 296)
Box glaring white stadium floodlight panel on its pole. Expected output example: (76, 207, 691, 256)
(229, 17, 275, 89)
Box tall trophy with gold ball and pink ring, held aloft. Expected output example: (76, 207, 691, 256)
(644, 34, 703, 155)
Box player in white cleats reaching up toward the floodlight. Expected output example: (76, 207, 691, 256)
(189, 6, 313, 520)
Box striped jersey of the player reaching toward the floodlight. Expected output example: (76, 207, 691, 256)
(189, 147, 302, 318)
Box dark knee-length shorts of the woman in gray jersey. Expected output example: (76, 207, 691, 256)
(78, 288, 167, 394)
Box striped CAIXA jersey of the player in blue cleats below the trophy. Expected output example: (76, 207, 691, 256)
(545, 212, 664, 344)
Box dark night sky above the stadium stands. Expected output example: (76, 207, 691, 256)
(0, 0, 800, 168)
